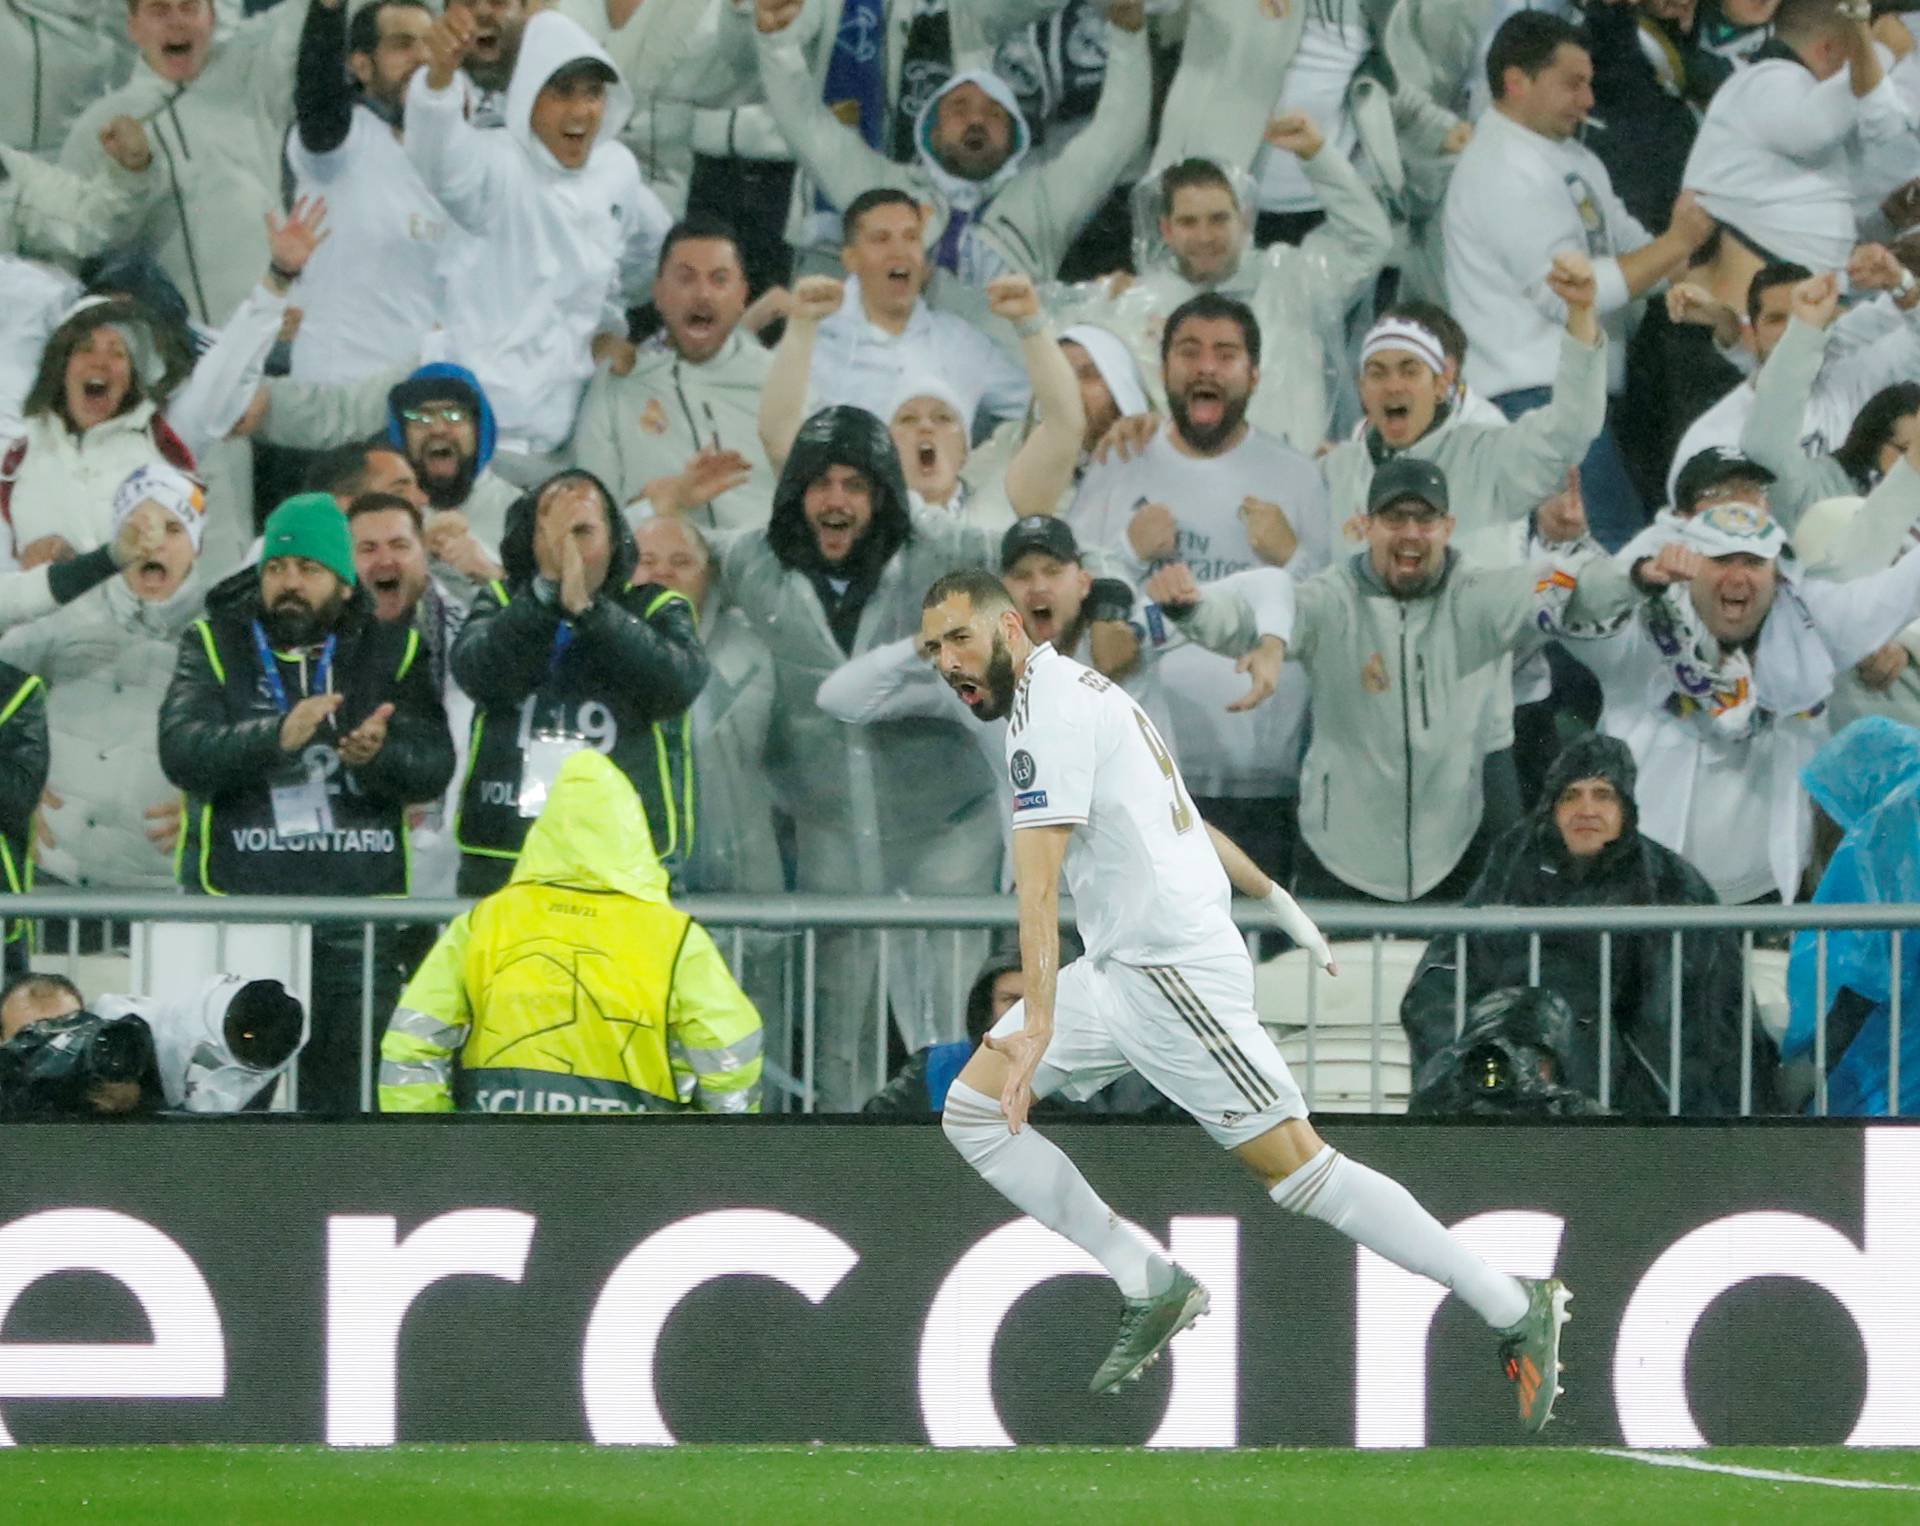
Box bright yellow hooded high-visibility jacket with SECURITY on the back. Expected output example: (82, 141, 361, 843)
(380, 751, 760, 1113)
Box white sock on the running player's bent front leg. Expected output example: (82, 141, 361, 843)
(941, 1081, 1173, 1298)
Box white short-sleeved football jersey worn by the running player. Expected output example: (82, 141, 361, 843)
(1006, 645, 1246, 964)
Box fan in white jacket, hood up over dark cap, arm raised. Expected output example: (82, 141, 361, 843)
(405, 6, 672, 453)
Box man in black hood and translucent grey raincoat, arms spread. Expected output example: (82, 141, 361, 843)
(668, 407, 1000, 1111)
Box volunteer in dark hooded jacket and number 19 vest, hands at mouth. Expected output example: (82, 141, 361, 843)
(453, 470, 707, 894)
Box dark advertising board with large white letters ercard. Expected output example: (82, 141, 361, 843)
(0, 1115, 1920, 1443)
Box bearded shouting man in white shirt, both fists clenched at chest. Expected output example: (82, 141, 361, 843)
(1068, 292, 1332, 877)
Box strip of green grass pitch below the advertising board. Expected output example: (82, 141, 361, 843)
(0, 1445, 1920, 1526)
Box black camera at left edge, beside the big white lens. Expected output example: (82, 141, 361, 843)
(0, 1010, 161, 1121)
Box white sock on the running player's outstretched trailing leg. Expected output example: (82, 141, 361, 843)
(1267, 1144, 1526, 1330)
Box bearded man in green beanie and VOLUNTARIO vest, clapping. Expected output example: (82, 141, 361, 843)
(159, 493, 453, 1113)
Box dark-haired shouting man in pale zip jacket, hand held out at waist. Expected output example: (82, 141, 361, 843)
(572, 213, 774, 530)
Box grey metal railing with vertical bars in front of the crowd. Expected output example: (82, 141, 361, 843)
(8, 891, 1920, 1115)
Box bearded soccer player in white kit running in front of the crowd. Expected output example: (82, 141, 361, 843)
(920, 568, 1569, 1432)
